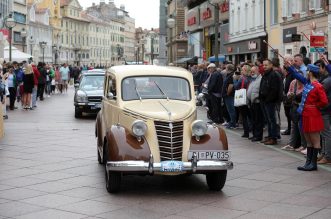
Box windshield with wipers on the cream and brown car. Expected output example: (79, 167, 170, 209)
(122, 76, 191, 101)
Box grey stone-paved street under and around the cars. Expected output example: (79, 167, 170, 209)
(0, 88, 331, 219)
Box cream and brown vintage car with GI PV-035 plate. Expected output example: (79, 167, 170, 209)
(95, 65, 233, 193)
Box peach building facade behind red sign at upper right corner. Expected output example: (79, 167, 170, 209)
(281, 0, 329, 62)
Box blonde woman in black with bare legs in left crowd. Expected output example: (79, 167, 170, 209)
(22, 64, 34, 110)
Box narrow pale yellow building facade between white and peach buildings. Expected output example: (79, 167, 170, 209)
(266, 1, 283, 58)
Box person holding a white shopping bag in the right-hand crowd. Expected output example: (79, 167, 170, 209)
(234, 64, 251, 138)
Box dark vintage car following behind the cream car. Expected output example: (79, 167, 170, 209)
(74, 70, 105, 118)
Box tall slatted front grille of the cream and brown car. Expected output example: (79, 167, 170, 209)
(154, 121, 183, 161)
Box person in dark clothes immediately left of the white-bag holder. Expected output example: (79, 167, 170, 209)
(222, 64, 237, 129)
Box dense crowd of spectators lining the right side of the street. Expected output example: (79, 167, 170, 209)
(189, 54, 331, 171)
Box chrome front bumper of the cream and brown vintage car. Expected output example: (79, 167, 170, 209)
(106, 153, 233, 174)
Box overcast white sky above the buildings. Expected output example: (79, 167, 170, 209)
(78, 0, 160, 29)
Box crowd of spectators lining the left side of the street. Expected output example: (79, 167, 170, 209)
(0, 59, 82, 119)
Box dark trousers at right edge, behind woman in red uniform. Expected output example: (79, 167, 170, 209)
(321, 114, 331, 161)
